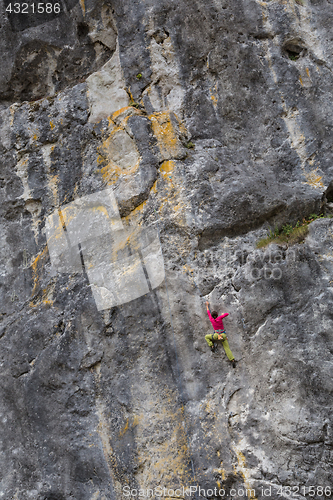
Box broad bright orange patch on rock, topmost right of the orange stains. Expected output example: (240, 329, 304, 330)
(149, 111, 182, 160)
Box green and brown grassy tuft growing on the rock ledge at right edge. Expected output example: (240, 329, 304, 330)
(256, 214, 332, 248)
